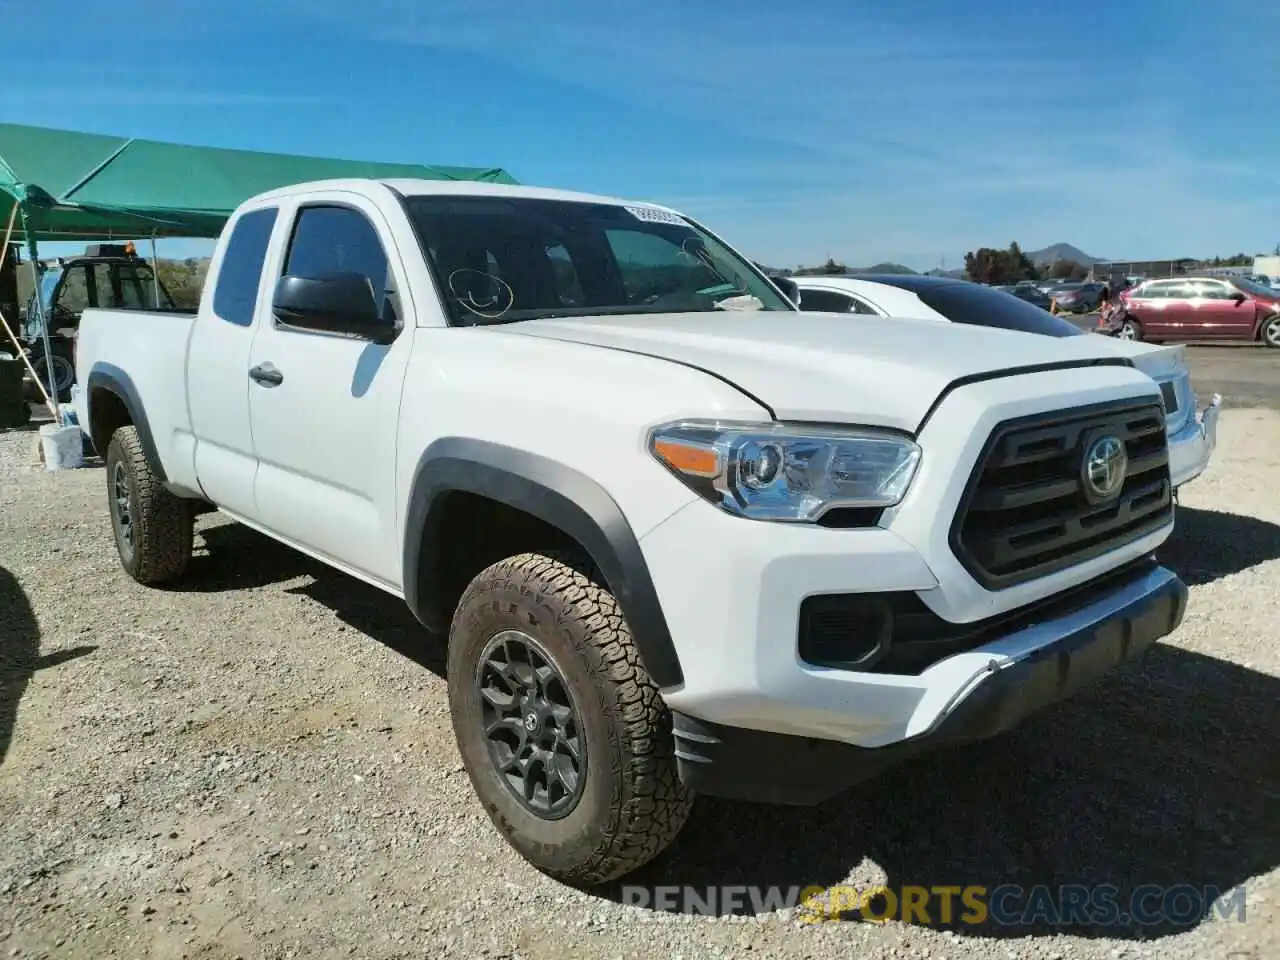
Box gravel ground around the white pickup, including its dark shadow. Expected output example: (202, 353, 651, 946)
(0, 410, 1280, 960)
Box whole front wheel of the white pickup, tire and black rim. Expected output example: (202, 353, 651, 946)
(448, 553, 692, 886)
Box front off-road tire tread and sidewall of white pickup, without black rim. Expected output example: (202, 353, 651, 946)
(448, 553, 694, 887)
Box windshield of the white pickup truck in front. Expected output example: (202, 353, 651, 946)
(404, 196, 795, 325)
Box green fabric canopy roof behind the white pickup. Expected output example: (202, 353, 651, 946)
(0, 123, 516, 239)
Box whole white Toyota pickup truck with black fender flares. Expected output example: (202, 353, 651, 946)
(77, 180, 1187, 883)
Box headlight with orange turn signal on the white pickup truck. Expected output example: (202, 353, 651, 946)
(649, 420, 920, 524)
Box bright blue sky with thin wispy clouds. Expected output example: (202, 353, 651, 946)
(0, 0, 1280, 269)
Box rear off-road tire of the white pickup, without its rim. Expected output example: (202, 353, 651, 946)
(106, 426, 195, 585)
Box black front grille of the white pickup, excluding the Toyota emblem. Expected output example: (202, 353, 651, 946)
(951, 398, 1174, 590)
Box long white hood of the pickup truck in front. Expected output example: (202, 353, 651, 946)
(489, 311, 1141, 431)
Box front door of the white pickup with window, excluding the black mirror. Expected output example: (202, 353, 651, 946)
(241, 191, 413, 589)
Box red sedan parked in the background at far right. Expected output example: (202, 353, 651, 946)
(1110, 276, 1280, 348)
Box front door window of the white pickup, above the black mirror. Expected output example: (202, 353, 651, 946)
(284, 206, 399, 324)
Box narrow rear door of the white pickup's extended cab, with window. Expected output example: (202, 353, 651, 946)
(186, 206, 279, 516)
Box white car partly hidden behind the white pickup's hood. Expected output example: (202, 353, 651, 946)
(791, 274, 1222, 489)
